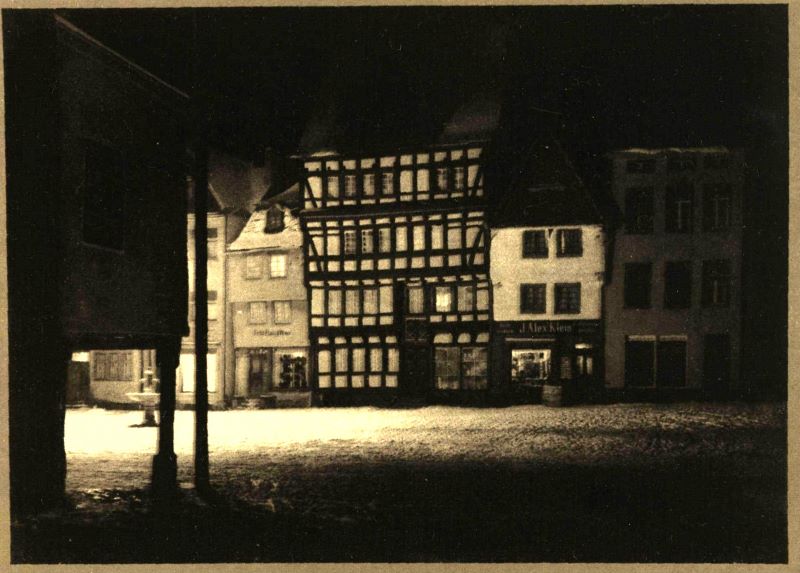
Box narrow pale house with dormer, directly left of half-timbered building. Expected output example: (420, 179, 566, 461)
(226, 184, 310, 406)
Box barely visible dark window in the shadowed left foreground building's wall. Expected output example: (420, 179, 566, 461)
(83, 142, 125, 250)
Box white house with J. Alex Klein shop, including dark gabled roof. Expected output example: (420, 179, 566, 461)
(490, 143, 606, 402)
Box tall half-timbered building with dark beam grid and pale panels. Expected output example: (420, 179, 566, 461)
(300, 143, 491, 403)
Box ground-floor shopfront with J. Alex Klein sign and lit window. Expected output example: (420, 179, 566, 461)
(492, 320, 603, 395)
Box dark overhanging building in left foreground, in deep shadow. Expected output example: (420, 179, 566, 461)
(3, 10, 187, 515)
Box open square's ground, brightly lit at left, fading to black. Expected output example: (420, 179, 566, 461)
(12, 404, 786, 562)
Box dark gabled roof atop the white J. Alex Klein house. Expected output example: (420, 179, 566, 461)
(490, 140, 603, 227)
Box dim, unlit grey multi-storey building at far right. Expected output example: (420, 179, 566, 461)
(605, 147, 745, 392)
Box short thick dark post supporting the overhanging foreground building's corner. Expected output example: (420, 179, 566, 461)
(152, 338, 181, 499)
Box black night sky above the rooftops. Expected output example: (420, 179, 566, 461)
(57, 6, 788, 171)
